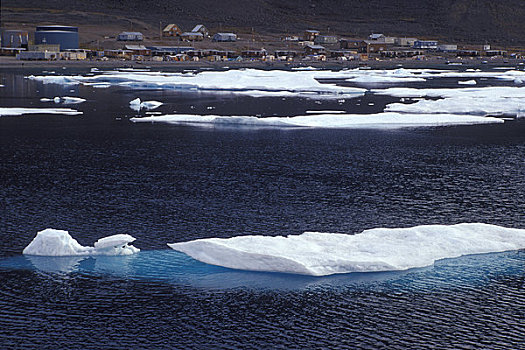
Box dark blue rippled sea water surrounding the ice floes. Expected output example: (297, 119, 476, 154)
(0, 65, 525, 349)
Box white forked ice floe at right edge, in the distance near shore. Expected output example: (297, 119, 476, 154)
(372, 86, 525, 115)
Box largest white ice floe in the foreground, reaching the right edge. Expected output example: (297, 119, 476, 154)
(168, 223, 525, 276)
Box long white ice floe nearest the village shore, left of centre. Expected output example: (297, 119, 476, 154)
(28, 69, 366, 98)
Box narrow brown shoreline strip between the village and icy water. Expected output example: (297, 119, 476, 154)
(0, 56, 524, 71)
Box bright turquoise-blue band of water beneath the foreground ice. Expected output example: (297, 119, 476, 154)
(0, 250, 525, 292)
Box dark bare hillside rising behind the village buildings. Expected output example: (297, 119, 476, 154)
(1, 0, 525, 48)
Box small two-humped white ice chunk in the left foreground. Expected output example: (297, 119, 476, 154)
(23, 228, 140, 256)
